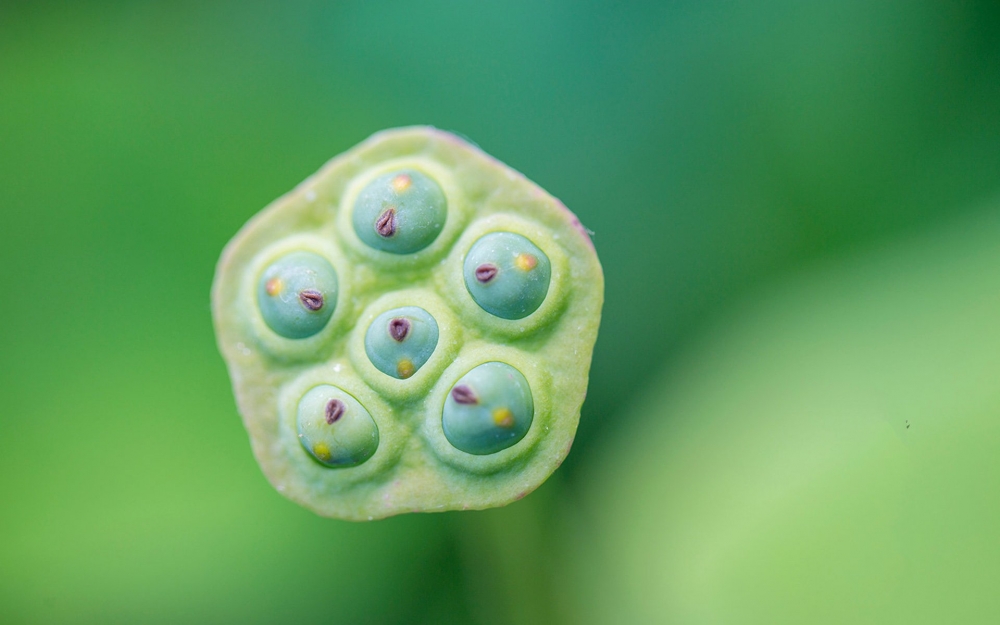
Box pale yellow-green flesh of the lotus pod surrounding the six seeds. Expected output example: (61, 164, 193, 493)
(212, 127, 604, 520)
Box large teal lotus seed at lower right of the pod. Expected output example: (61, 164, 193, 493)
(441, 362, 535, 456)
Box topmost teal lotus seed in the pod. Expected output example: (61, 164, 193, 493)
(354, 169, 448, 254)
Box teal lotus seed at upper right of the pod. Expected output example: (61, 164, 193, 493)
(464, 232, 552, 319)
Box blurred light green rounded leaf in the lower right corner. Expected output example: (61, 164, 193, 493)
(564, 211, 1000, 625)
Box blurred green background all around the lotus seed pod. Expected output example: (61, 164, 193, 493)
(0, 0, 1000, 624)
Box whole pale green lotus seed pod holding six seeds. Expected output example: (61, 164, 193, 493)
(212, 127, 604, 520)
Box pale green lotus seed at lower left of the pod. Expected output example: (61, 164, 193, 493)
(296, 384, 378, 468)
